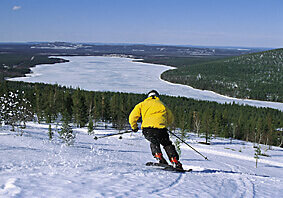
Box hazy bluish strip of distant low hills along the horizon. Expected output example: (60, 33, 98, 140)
(0, 42, 263, 58)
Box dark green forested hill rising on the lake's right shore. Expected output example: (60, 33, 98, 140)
(160, 49, 283, 102)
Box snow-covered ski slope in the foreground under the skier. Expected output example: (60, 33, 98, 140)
(0, 123, 283, 198)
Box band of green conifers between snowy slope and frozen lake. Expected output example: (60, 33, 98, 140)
(0, 82, 283, 146)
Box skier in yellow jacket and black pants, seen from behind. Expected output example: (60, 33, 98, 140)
(129, 90, 183, 170)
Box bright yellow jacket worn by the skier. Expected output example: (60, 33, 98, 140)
(129, 97, 174, 129)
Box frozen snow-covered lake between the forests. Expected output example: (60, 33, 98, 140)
(10, 56, 283, 111)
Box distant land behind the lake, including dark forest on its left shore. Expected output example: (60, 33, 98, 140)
(0, 42, 266, 82)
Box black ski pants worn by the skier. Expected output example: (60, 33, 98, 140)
(142, 128, 179, 160)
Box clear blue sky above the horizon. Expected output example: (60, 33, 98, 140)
(0, 0, 283, 48)
